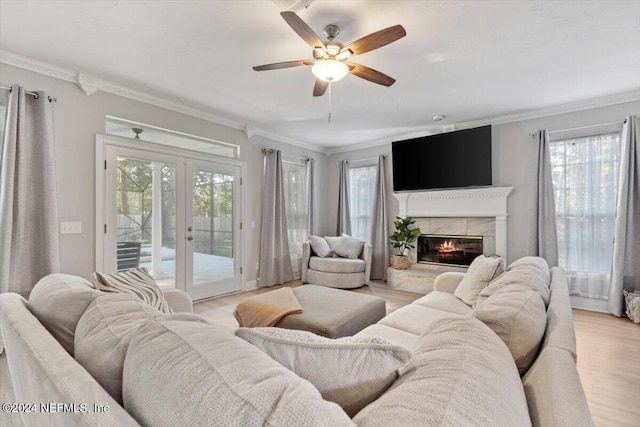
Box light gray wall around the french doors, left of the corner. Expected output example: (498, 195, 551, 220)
(0, 64, 327, 282)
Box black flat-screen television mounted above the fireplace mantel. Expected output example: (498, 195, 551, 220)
(391, 126, 491, 191)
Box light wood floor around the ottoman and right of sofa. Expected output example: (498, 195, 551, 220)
(194, 281, 640, 427)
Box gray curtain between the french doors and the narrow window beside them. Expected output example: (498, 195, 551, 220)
(258, 150, 293, 287)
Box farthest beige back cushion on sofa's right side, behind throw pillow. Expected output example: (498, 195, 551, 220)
(476, 257, 551, 307)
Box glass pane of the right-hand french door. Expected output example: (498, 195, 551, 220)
(192, 169, 234, 285)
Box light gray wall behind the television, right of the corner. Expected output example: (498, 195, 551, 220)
(328, 102, 640, 260)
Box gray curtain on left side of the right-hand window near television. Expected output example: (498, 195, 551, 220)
(537, 130, 558, 267)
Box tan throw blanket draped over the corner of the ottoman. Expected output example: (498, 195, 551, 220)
(233, 288, 302, 328)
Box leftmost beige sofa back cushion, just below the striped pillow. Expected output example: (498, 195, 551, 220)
(29, 274, 102, 356)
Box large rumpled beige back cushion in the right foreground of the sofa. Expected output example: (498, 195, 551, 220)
(353, 316, 531, 426)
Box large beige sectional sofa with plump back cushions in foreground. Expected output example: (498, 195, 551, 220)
(0, 258, 592, 426)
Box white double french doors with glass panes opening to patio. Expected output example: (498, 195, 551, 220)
(98, 144, 242, 300)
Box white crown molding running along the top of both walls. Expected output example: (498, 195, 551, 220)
(0, 50, 640, 156)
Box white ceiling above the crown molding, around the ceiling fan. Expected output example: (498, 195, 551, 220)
(0, 0, 640, 148)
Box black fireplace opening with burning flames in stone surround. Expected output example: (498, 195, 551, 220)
(417, 234, 483, 266)
